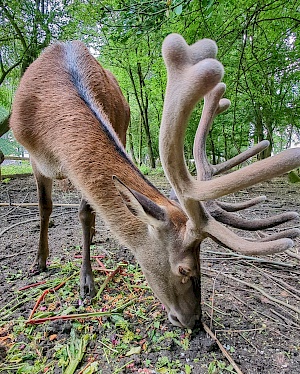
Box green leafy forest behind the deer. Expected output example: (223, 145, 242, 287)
(0, 0, 300, 168)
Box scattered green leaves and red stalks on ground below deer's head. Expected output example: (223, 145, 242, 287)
(0, 251, 213, 374)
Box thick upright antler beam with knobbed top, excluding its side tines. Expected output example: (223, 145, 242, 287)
(159, 34, 223, 226)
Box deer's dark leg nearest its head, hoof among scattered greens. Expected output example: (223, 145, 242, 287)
(79, 199, 96, 298)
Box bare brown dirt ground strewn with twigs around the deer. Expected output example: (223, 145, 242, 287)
(0, 176, 300, 374)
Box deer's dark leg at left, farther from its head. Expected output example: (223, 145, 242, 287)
(32, 162, 52, 271)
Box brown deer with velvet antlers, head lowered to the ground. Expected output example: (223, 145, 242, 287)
(10, 34, 300, 329)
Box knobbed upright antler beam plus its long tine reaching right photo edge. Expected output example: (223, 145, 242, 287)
(159, 34, 300, 207)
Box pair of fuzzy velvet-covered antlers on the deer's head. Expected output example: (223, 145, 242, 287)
(160, 34, 300, 254)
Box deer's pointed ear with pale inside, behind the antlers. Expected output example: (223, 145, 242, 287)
(113, 175, 166, 227)
